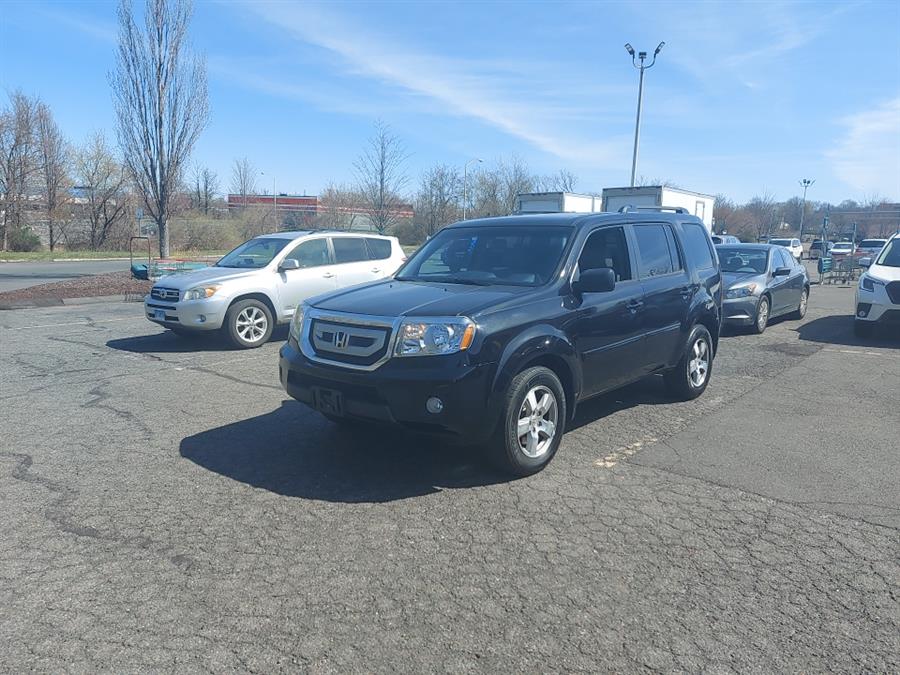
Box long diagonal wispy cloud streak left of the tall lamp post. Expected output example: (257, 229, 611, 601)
(229, 2, 627, 166)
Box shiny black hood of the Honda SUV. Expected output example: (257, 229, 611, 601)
(312, 279, 534, 317)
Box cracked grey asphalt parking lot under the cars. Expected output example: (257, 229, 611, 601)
(0, 287, 900, 672)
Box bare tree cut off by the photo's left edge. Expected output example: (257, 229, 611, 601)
(0, 91, 38, 251)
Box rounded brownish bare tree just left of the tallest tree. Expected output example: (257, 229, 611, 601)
(75, 133, 128, 250)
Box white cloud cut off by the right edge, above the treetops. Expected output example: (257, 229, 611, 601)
(825, 96, 900, 199)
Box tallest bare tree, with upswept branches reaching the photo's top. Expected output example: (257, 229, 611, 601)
(110, 0, 209, 257)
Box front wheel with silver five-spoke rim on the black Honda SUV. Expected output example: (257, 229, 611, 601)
(490, 366, 568, 476)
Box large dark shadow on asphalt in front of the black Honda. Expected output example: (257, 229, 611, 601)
(180, 401, 507, 503)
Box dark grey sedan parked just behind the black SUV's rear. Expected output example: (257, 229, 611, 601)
(716, 244, 809, 333)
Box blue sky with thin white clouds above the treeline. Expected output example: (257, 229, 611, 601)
(0, 0, 900, 202)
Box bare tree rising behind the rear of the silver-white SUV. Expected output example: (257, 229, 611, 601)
(354, 121, 408, 233)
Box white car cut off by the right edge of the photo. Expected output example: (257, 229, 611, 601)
(853, 234, 900, 335)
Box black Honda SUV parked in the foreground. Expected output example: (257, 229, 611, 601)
(280, 207, 722, 475)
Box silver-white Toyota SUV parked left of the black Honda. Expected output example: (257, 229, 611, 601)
(144, 231, 406, 349)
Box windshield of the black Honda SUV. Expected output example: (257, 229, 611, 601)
(396, 226, 572, 286)
